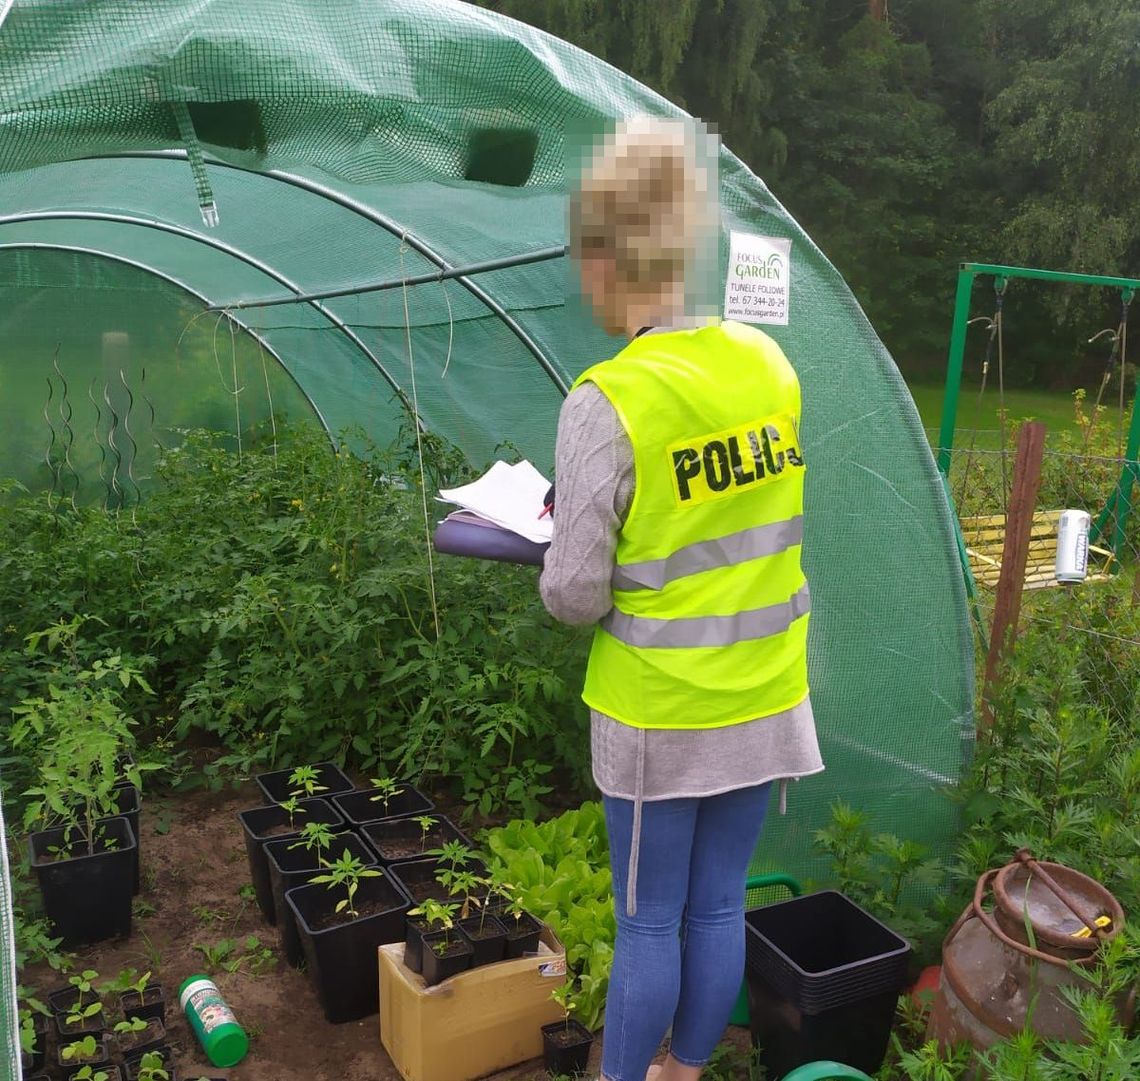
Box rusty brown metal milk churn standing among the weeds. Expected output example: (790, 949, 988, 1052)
(927, 848, 1131, 1049)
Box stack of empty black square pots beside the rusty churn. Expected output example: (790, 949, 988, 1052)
(744, 889, 910, 1078)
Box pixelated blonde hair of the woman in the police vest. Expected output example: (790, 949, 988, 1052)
(570, 119, 711, 298)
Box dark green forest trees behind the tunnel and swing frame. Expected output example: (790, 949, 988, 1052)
(478, 0, 1140, 390)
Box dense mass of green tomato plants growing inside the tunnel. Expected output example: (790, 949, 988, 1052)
(0, 429, 588, 814)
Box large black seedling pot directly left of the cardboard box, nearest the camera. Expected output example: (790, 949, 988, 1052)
(285, 868, 412, 1024)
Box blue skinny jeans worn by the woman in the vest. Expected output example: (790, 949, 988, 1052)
(602, 783, 772, 1081)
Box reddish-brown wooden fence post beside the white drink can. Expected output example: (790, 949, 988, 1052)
(978, 421, 1045, 737)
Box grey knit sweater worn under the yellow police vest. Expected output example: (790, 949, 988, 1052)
(539, 383, 823, 818)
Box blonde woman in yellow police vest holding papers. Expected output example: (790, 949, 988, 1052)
(540, 122, 823, 1081)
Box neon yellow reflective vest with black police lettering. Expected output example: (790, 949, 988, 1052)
(575, 322, 809, 729)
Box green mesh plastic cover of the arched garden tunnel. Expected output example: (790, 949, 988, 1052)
(0, 0, 972, 1053)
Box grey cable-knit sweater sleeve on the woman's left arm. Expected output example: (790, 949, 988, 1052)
(539, 383, 634, 626)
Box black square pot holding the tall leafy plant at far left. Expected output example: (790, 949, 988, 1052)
(29, 819, 135, 949)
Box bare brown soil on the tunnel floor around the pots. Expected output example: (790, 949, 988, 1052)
(21, 781, 601, 1081)
